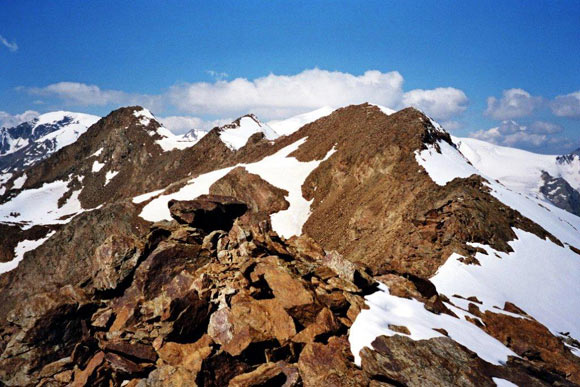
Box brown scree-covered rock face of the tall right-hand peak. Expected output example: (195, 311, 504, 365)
(276, 105, 555, 278)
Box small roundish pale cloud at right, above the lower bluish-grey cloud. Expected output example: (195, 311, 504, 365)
(484, 89, 542, 120)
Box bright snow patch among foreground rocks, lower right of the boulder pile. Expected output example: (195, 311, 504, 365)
(348, 283, 517, 366)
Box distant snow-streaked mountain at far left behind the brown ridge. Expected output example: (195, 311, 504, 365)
(0, 111, 100, 174)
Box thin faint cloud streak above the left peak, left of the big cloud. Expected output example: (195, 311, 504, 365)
(17, 82, 160, 110)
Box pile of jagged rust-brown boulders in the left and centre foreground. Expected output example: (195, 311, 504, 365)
(0, 197, 373, 386)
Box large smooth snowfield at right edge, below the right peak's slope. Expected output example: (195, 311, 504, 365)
(431, 228, 580, 339)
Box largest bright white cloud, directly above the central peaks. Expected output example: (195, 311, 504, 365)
(168, 68, 403, 119)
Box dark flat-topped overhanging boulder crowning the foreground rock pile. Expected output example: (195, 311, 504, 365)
(169, 195, 248, 232)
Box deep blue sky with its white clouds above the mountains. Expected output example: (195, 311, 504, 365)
(0, 0, 580, 153)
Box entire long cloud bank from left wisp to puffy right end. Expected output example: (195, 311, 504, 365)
(20, 68, 468, 120)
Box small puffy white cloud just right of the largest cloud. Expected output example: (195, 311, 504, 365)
(403, 87, 469, 120)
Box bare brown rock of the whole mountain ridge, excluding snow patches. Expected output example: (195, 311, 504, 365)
(0, 104, 580, 385)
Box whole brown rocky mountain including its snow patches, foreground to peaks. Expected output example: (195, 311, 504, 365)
(0, 104, 580, 386)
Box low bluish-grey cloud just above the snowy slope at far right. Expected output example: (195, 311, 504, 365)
(470, 120, 562, 147)
